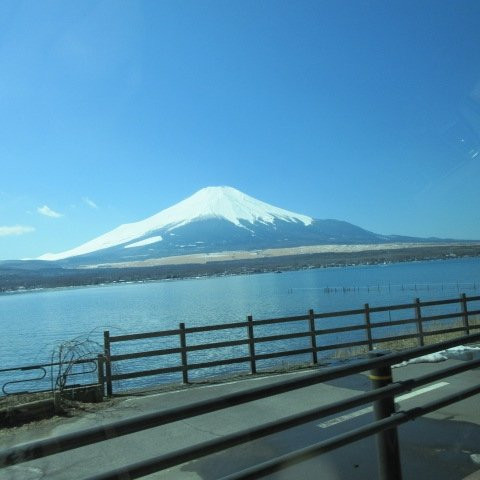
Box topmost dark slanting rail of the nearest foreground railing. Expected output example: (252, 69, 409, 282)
(0, 333, 480, 466)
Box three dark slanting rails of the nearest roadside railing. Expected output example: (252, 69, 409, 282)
(0, 333, 480, 480)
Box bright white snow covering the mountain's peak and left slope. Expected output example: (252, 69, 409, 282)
(38, 187, 313, 260)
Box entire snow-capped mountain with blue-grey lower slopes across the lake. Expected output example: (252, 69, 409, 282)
(39, 187, 438, 264)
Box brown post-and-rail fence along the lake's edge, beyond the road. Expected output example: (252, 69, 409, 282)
(104, 293, 480, 396)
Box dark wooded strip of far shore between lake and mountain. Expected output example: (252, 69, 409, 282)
(0, 244, 480, 295)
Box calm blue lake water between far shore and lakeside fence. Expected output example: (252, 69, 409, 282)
(0, 258, 480, 394)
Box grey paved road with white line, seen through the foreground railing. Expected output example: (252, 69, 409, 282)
(0, 360, 480, 480)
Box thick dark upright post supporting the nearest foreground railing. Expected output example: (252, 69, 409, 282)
(369, 351, 402, 480)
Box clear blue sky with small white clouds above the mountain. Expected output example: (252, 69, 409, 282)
(0, 0, 480, 259)
